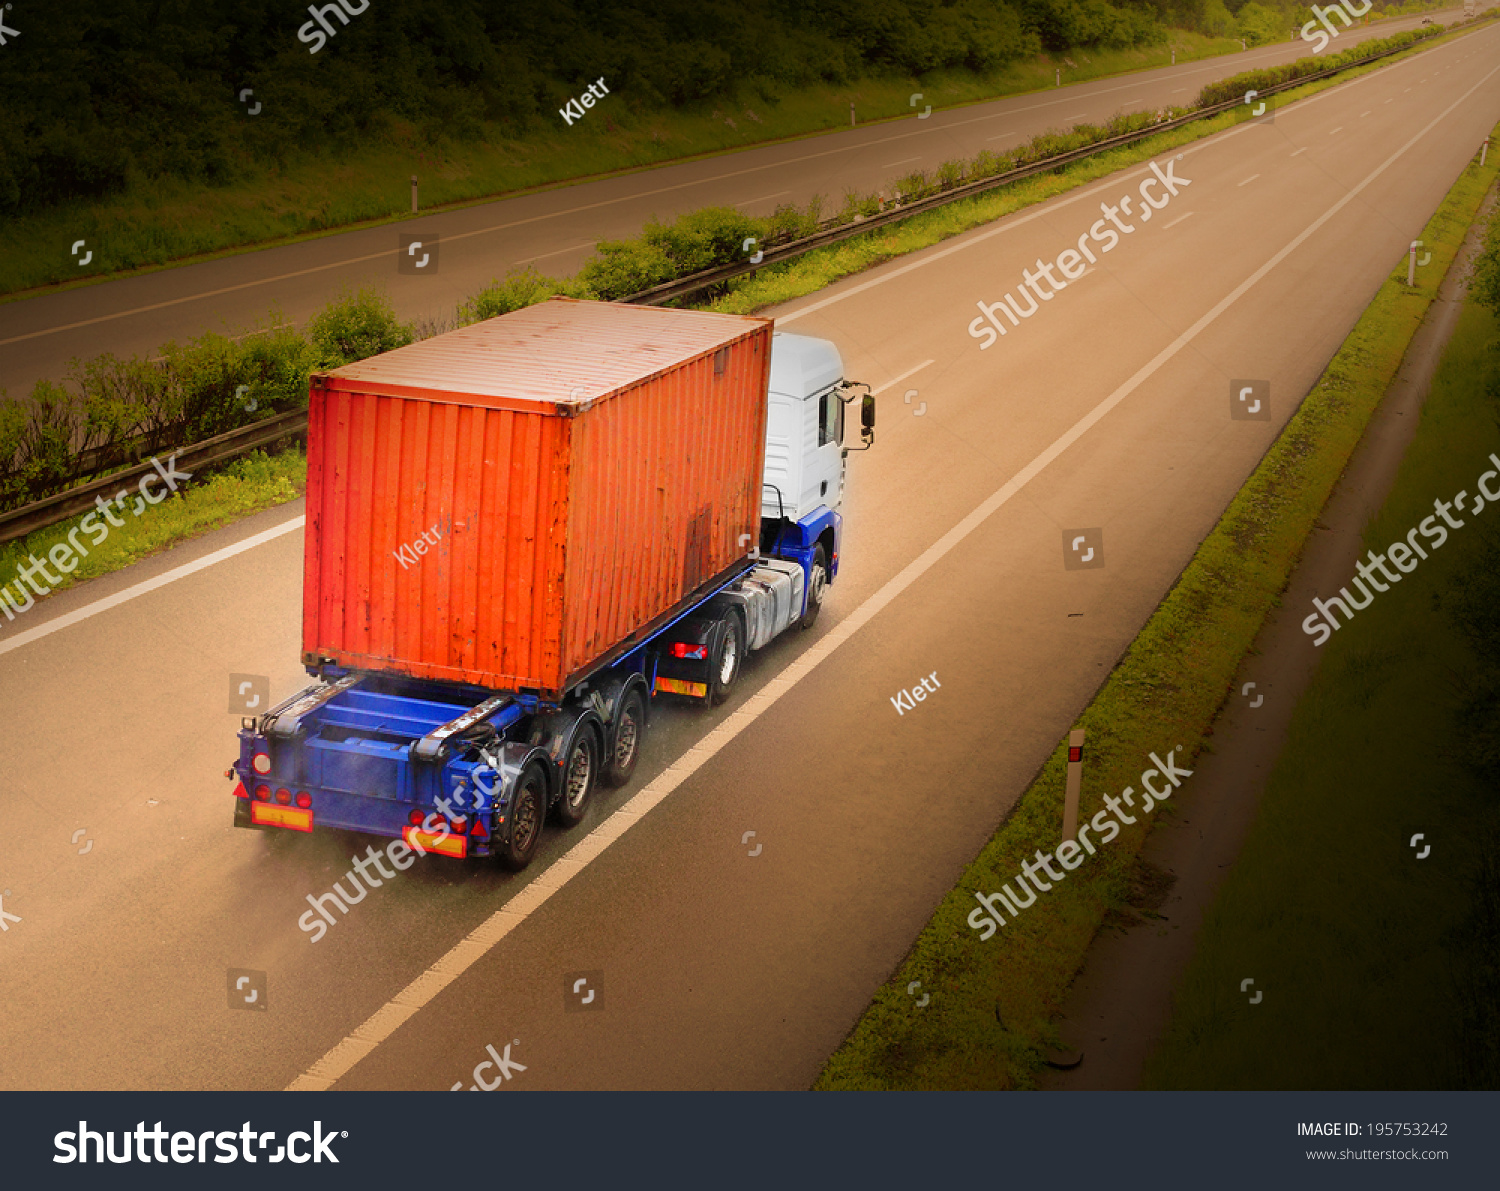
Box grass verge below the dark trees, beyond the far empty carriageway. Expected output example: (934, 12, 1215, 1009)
(0, 30, 1350, 294)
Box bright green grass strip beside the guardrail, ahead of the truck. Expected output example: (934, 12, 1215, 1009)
(707, 21, 1488, 315)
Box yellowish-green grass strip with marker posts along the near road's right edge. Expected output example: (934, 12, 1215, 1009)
(815, 127, 1500, 1089)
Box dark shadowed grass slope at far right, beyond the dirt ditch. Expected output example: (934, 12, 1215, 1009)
(1145, 285, 1500, 1089)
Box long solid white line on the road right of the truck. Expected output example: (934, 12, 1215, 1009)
(287, 66, 1500, 1092)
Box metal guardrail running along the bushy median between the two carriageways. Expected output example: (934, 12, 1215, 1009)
(0, 26, 1452, 543)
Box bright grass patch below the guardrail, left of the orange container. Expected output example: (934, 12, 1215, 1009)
(0, 449, 308, 612)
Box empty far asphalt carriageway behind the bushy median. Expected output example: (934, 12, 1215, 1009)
(0, 6, 1463, 399)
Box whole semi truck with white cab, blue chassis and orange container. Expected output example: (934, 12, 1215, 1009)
(225, 299, 875, 872)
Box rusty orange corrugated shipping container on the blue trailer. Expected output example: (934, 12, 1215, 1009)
(303, 299, 771, 701)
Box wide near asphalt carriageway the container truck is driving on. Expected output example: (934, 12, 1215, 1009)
(0, 18, 1500, 1089)
